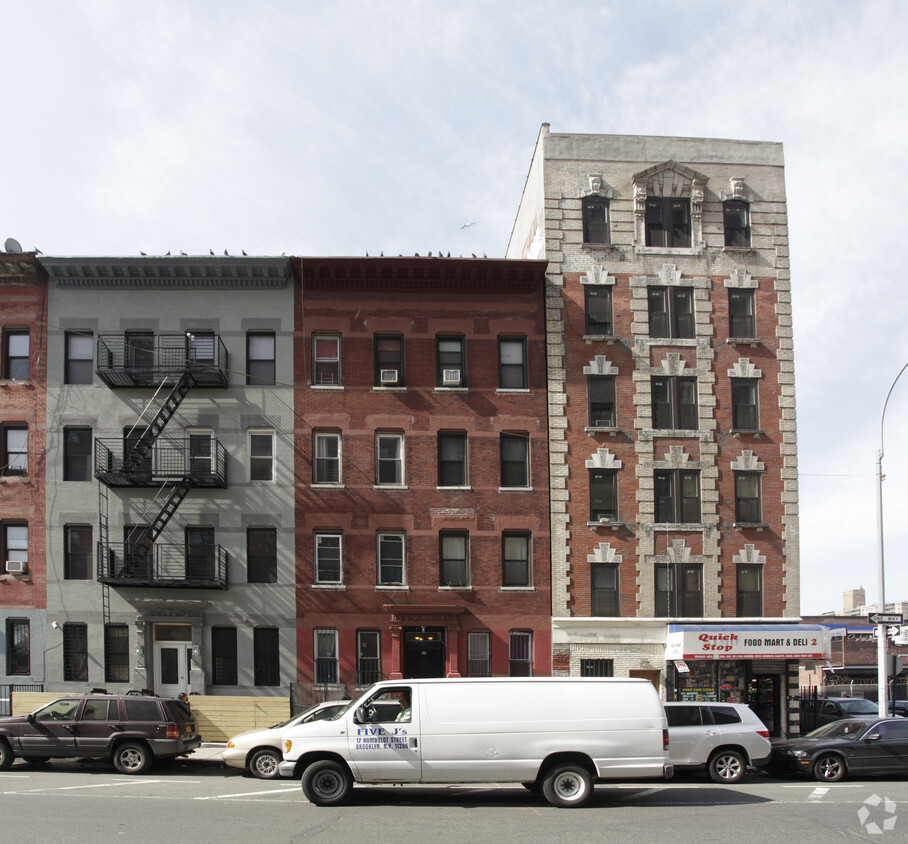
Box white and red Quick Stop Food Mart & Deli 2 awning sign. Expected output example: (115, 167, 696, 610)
(665, 624, 829, 660)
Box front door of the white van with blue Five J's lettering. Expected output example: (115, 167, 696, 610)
(347, 684, 422, 782)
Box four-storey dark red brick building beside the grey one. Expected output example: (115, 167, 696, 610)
(294, 257, 551, 694)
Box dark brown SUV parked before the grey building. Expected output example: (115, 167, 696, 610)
(0, 695, 202, 774)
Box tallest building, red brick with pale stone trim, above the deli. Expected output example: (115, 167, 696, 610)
(507, 125, 828, 734)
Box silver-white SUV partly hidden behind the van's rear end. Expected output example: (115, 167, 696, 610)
(665, 701, 772, 784)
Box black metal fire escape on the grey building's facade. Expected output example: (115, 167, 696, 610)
(94, 332, 228, 596)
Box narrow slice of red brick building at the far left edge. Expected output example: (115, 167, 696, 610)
(0, 253, 47, 684)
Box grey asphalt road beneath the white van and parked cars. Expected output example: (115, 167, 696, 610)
(0, 761, 908, 844)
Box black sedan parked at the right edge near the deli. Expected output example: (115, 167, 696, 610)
(767, 718, 908, 782)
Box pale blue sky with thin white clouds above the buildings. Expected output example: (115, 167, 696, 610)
(0, 0, 908, 615)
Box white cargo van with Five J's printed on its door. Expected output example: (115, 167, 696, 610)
(279, 677, 672, 806)
